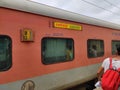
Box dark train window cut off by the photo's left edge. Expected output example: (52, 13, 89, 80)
(0, 35, 12, 71)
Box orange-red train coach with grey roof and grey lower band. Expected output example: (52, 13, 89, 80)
(0, 0, 120, 90)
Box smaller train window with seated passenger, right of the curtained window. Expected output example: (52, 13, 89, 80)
(87, 39, 104, 58)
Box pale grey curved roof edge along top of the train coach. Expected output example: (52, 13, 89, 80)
(0, 0, 120, 30)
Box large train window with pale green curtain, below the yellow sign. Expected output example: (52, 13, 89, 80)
(42, 38, 74, 64)
